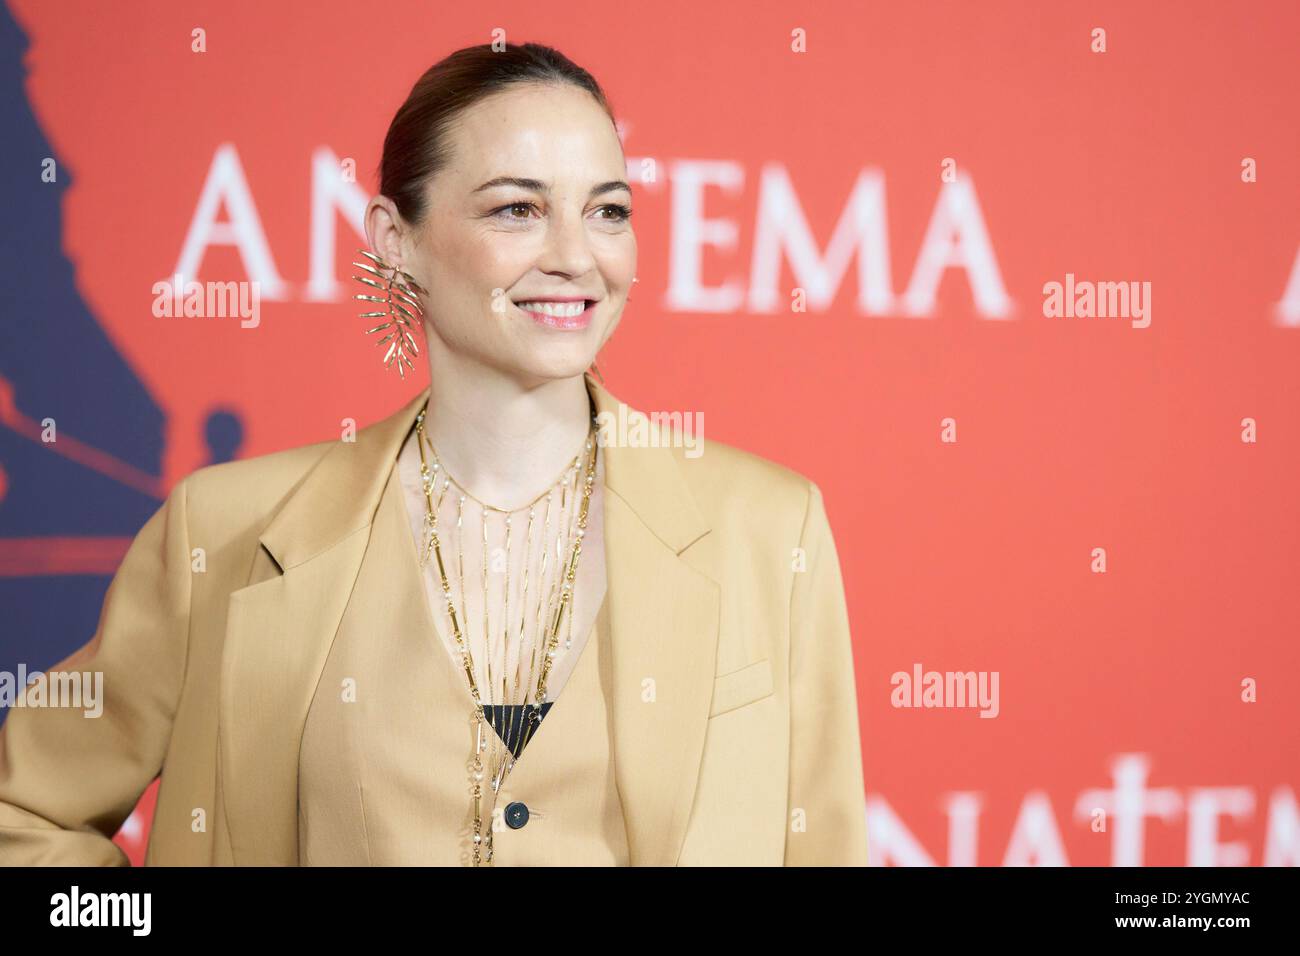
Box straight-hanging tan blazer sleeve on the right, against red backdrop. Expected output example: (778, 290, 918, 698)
(785, 483, 867, 866)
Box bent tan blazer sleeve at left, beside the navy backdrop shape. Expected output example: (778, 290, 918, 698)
(0, 481, 191, 866)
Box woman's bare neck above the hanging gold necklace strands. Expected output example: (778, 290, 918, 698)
(425, 349, 592, 509)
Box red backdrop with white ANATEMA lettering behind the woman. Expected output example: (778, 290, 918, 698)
(9, 0, 1300, 865)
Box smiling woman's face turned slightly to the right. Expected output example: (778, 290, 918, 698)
(379, 85, 637, 384)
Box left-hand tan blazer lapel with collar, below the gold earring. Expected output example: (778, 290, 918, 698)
(217, 389, 429, 866)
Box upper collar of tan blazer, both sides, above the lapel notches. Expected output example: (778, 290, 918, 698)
(259, 372, 709, 571)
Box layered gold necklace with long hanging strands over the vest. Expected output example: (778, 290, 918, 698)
(416, 407, 597, 866)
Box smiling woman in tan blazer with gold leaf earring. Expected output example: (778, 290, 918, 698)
(0, 44, 866, 865)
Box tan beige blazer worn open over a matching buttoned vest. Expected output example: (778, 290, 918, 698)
(0, 375, 867, 866)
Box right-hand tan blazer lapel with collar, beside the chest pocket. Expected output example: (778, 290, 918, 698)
(588, 377, 720, 866)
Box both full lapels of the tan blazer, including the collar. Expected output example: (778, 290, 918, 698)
(217, 375, 719, 866)
